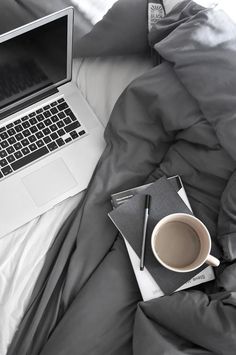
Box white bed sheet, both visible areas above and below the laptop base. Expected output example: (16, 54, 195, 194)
(0, 56, 151, 355)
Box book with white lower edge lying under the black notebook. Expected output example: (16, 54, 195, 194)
(109, 175, 215, 301)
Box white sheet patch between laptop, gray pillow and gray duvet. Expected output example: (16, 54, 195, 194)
(74, 55, 152, 126)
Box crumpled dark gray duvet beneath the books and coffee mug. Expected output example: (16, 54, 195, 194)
(8, 1, 236, 355)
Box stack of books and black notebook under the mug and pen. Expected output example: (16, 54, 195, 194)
(108, 176, 215, 301)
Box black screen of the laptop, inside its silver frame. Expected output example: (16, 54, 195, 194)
(0, 16, 68, 110)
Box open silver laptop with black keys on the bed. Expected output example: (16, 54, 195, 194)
(0, 7, 105, 237)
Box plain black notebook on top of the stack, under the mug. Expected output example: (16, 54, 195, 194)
(109, 177, 207, 294)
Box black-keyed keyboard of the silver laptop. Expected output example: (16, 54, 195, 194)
(0, 98, 86, 179)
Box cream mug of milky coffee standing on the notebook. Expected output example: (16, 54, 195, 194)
(151, 213, 220, 272)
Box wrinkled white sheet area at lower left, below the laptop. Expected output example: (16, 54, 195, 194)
(0, 196, 78, 355)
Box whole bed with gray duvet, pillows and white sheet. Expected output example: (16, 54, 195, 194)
(0, 0, 236, 355)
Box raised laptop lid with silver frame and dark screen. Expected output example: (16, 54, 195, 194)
(0, 7, 73, 120)
